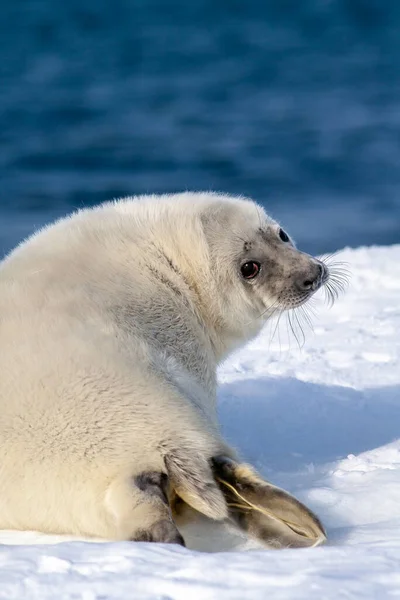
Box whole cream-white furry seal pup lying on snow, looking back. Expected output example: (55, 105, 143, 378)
(0, 193, 338, 547)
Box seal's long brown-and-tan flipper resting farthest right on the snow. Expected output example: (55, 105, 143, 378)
(212, 456, 326, 548)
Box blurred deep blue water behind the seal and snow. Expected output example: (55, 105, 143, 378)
(0, 0, 400, 256)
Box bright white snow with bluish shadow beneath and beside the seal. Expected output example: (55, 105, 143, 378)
(0, 246, 400, 600)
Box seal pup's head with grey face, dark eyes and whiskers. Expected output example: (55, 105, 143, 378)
(197, 197, 344, 346)
